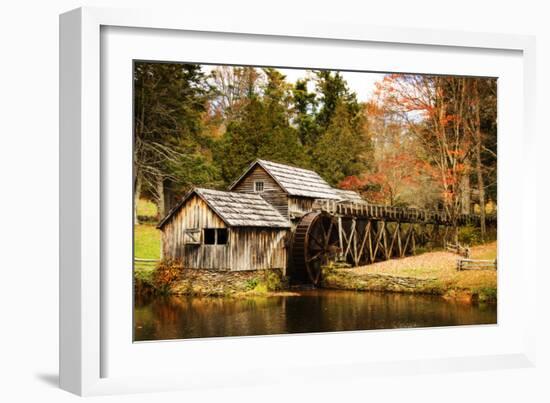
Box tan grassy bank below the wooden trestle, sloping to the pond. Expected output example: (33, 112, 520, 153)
(323, 242, 497, 302)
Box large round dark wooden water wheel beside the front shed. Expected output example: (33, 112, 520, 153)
(290, 212, 339, 285)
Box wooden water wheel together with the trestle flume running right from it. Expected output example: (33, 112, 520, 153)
(290, 200, 496, 285)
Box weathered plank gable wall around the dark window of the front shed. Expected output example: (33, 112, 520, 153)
(162, 195, 231, 270)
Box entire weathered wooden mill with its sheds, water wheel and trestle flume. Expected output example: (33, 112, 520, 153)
(158, 160, 496, 285)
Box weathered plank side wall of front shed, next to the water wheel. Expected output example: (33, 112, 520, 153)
(229, 227, 289, 274)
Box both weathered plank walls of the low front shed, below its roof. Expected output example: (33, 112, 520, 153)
(162, 195, 289, 273)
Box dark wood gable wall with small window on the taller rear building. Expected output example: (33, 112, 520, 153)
(231, 166, 288, 218)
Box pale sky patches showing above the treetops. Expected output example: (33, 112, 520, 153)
(203, 66, 384, 102)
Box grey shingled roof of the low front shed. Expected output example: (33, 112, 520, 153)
(158, 188, 290, 228)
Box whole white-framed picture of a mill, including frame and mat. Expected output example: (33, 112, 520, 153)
(60, 9, 535, 395)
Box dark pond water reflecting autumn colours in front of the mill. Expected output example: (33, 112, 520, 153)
(134, 290, 497, 341)
